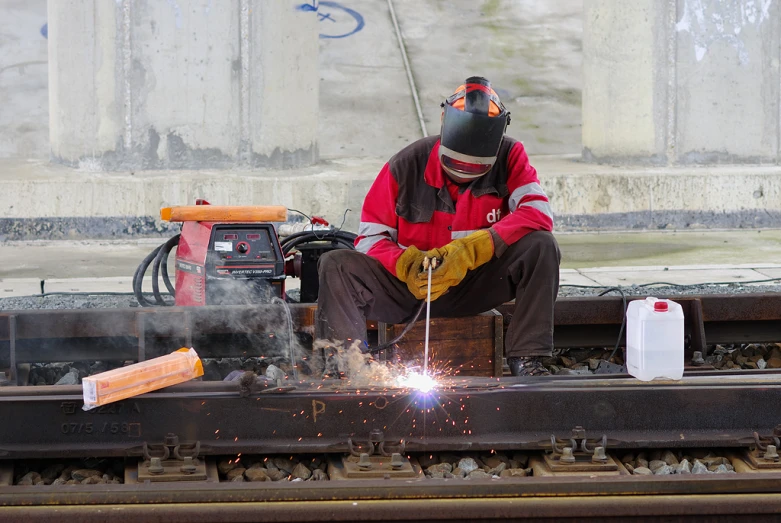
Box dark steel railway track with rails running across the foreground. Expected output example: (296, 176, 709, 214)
(0, 295, 781, 523)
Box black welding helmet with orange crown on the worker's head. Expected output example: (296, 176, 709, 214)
(439, 76, 510, 179)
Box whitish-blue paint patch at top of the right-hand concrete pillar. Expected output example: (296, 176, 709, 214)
(675, 0, 773, 65)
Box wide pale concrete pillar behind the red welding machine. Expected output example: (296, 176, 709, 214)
(48, 0, 319, 170)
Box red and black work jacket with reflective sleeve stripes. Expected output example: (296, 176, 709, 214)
(355, 136, 553, 275)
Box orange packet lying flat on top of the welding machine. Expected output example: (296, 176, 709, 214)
(160, 205, 287, 222)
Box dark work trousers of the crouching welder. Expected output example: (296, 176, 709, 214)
(315, 231, 561, 357)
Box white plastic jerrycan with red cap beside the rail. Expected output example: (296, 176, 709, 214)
(626, 298, 684, 381)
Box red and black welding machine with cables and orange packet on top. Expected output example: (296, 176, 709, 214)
(133, 200, 355, 306)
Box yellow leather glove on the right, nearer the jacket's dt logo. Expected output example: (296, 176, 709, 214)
(415, 229, 494, 301)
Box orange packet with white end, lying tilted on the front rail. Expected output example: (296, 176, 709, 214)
(82, 348, 203, 410)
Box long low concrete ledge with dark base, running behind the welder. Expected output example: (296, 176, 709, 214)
(0, 155, 781, 241)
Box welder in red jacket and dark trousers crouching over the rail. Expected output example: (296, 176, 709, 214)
(315, 76, 561, 376)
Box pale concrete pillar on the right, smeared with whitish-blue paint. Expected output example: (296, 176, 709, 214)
(583, 0, 781, 164)
